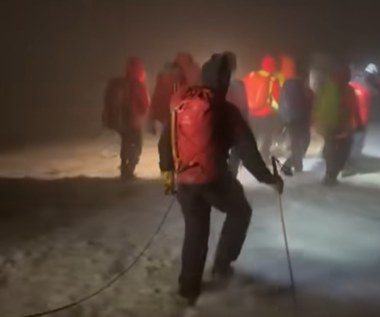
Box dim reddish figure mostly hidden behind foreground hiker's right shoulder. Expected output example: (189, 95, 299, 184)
(225, 52, 248, 177)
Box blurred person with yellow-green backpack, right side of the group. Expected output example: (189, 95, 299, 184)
(315, 65, 363, 186)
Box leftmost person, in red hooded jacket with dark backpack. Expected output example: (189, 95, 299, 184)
(102, 57, 149, 180)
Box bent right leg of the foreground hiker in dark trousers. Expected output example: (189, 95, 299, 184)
(205, 179, 252, 275)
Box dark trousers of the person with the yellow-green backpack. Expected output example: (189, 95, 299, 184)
(323, 135, 352, 179)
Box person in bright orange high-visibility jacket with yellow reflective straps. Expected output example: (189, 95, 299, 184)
(243, 55, 280, 164)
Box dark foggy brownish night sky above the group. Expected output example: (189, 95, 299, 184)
(0, 0, 380, 147)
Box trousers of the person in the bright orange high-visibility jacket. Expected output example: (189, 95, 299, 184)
(249, 114, 279, 164)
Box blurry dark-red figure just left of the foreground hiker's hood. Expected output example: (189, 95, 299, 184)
(148, 52, 201, 134)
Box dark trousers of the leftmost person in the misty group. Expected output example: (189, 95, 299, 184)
(120, 128, 143, 173)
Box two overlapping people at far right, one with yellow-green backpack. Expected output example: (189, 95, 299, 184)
(313, 62, 377, 185)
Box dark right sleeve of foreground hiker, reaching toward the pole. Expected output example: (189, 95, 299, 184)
(230, 105, 276, 184)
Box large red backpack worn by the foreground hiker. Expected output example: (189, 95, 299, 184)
(171, 87, 217, 184)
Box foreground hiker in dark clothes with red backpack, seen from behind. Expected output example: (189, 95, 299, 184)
(158, 54, 283, 304)
